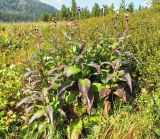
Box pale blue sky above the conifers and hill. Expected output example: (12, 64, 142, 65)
(41, 0, 146, 9)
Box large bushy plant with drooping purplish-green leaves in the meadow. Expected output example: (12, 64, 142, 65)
(17, 14, 136, 139)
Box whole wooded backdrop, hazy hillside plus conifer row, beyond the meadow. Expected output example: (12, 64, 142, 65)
(0, 0, 146, 22)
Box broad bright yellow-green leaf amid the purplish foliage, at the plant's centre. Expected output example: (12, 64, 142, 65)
(64, 66, 81, 77)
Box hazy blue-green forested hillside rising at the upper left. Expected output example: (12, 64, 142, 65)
(0, 0, 57, 21)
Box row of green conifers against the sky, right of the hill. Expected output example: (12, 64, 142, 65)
(40, 0, 147, 21)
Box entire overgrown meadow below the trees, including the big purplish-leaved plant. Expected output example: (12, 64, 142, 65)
(0, 7, 160, 139)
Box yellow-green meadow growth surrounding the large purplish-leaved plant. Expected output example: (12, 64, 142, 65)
(0, 5, 160, 139)
